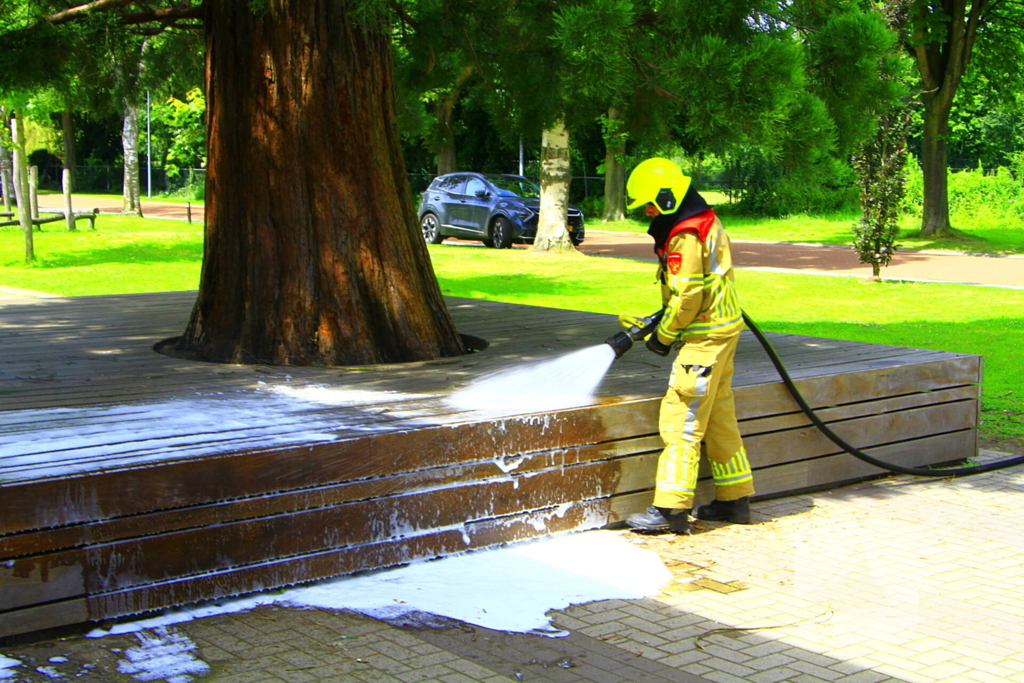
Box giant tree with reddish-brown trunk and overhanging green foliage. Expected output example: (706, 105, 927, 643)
(0, 0, 974, 365)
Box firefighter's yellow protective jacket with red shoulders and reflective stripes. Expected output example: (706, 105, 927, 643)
(657, 209, 743, 344)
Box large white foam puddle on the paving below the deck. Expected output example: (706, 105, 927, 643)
(88, 532, 671, 638)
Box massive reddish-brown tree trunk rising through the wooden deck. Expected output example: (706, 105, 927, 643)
(175, 0, 464, 366)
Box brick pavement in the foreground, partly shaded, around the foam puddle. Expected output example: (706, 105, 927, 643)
(0, 452, 1024, 683)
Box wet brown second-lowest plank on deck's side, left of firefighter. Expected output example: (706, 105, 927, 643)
(0, 457, 654, 607)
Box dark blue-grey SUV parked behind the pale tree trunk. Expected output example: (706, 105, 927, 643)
(419, 173, 584, 249)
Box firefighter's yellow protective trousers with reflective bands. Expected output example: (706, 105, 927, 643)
(654, 334, 754, 509)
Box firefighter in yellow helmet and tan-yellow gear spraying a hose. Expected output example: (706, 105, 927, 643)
(621, 159, 754, 533)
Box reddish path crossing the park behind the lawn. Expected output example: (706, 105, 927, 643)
(46, 195, 1024, 289)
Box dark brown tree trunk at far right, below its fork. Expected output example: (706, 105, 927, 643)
(921, 94, 952, 236)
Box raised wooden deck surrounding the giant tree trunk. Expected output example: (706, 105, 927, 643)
(0, 293, 981, 637)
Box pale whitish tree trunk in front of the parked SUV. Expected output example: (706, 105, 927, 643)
(534, 121, 575, 251)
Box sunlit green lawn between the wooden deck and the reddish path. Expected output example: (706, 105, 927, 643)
(0, 215, 1024, 445)
